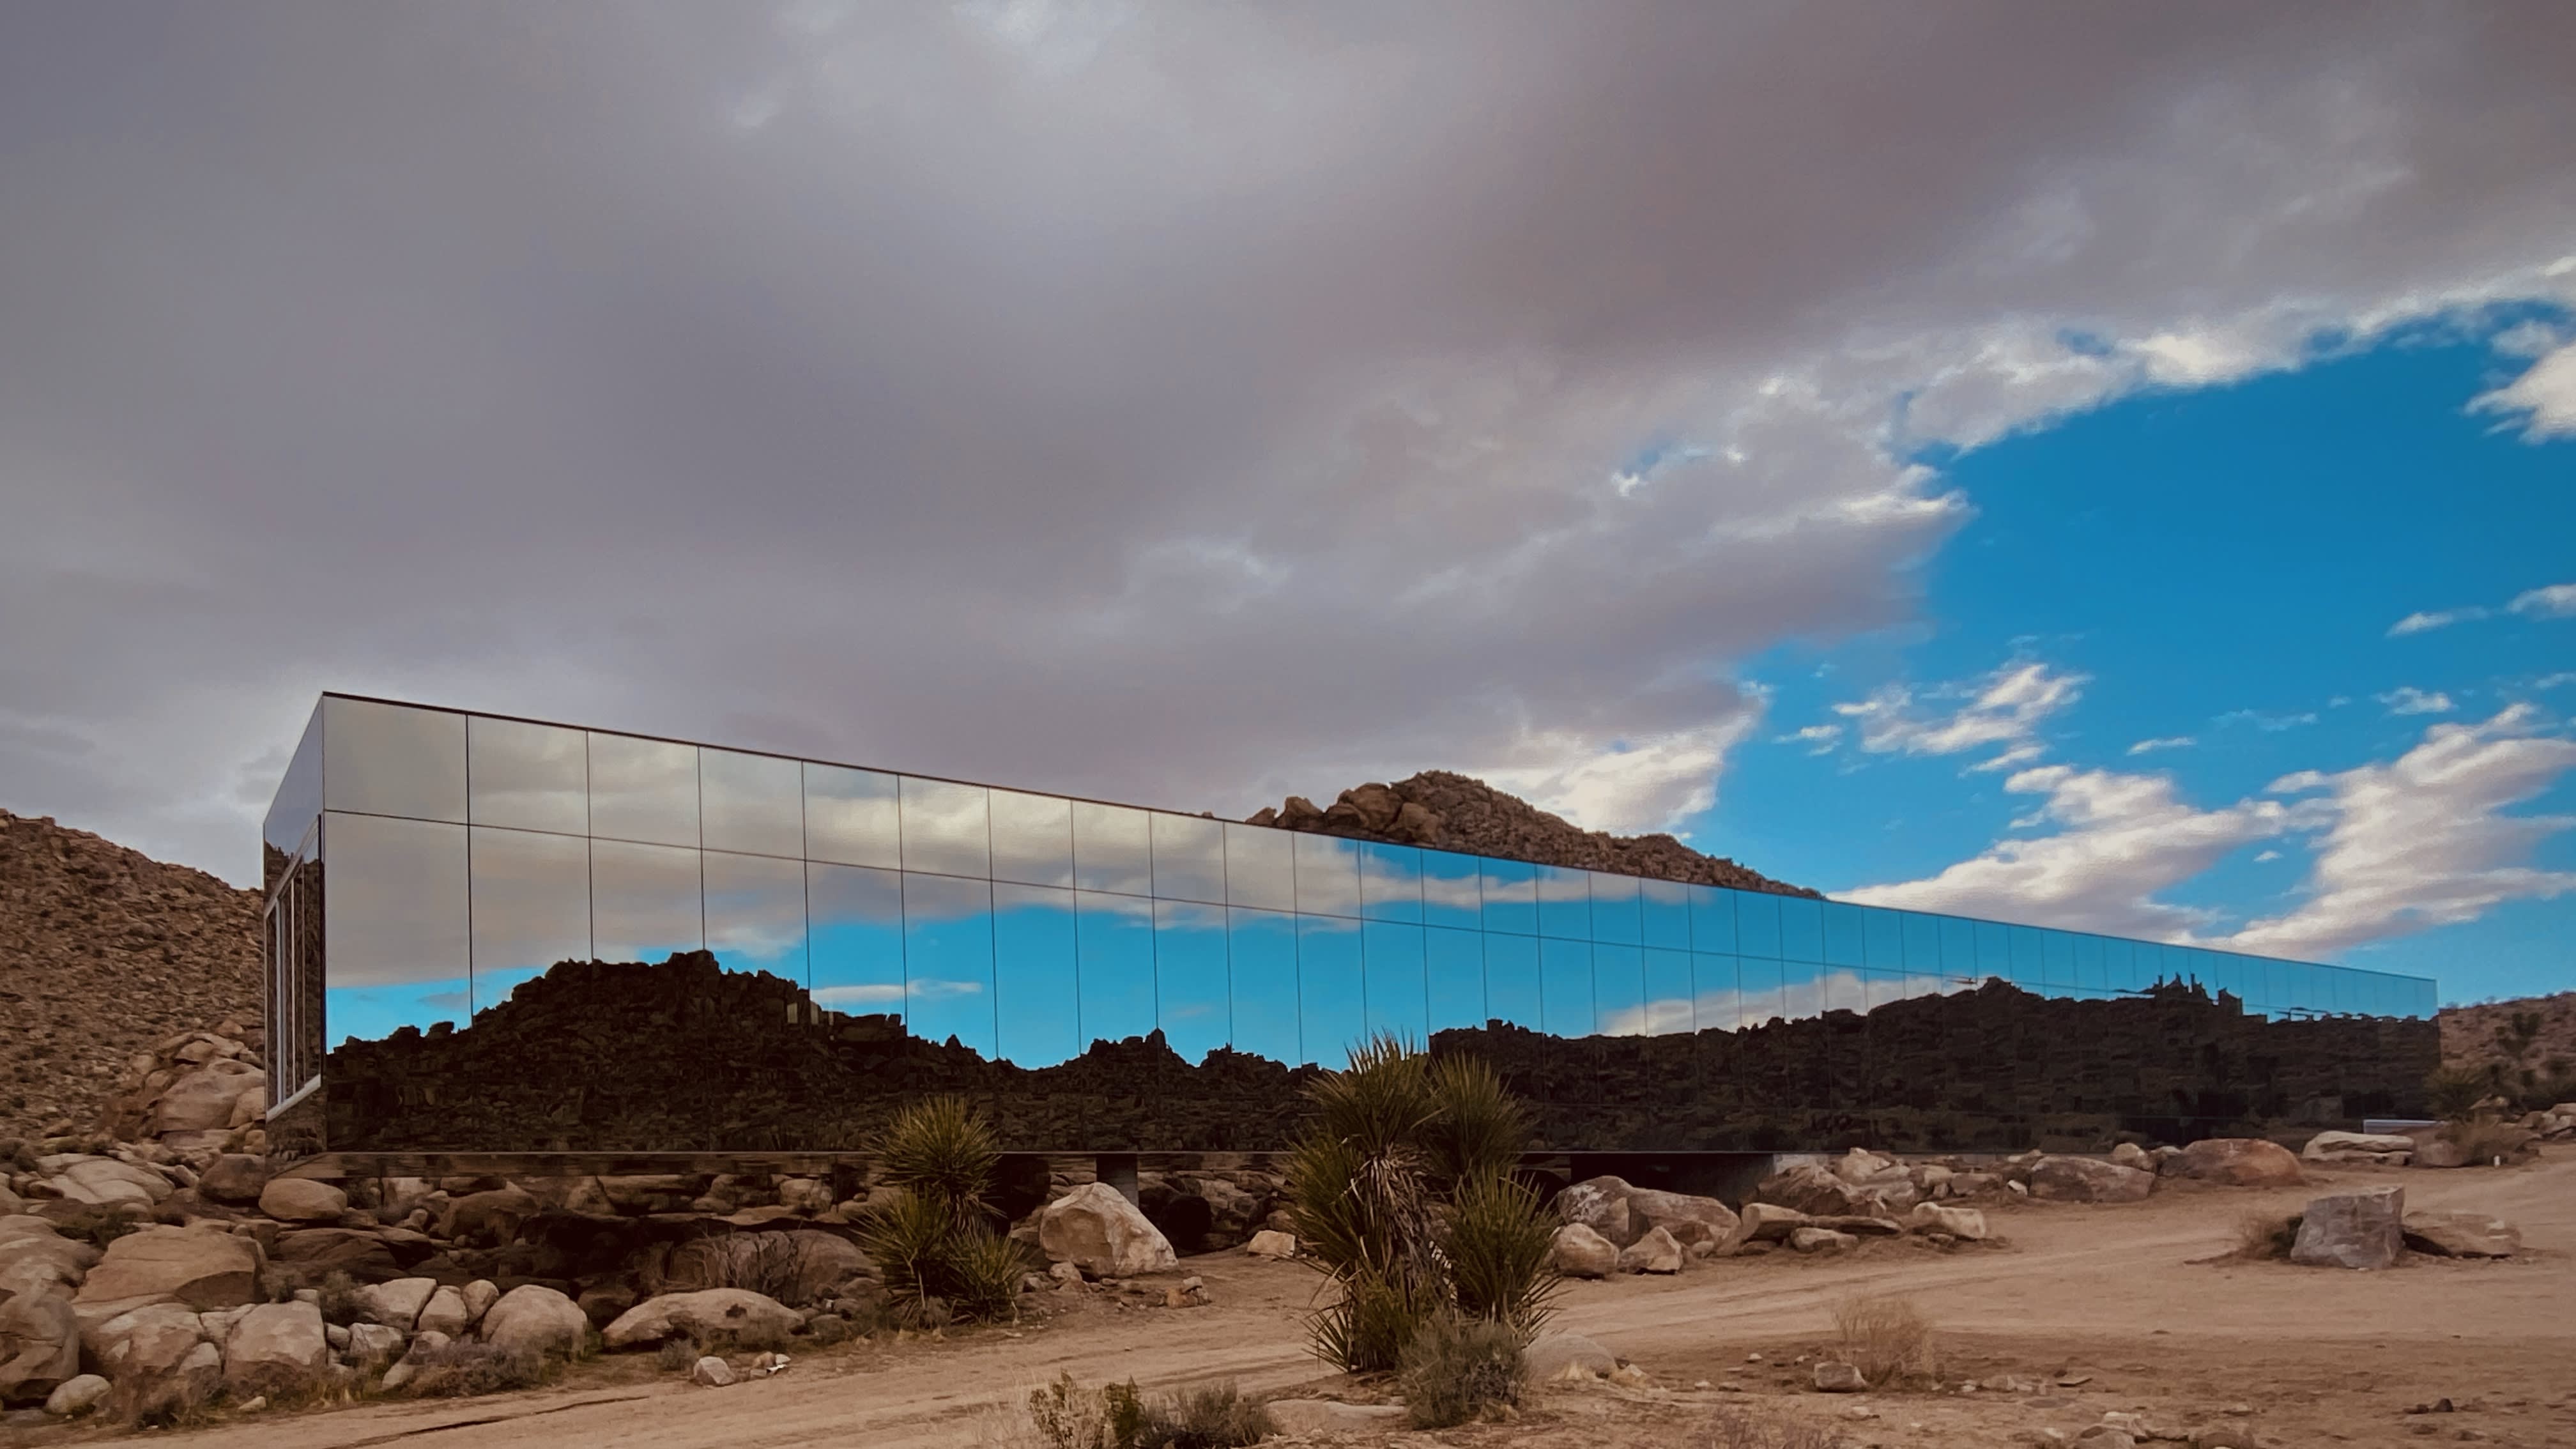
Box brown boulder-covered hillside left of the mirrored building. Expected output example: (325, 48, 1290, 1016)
(0, 809, 260, 1137)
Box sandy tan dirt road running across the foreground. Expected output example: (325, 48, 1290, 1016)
(54, 1150, 2576, 1449)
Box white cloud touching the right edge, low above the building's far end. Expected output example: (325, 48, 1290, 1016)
(2231, 704, 2576, 959)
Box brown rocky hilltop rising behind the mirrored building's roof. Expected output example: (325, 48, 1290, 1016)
(1250, 771, 1819, 894)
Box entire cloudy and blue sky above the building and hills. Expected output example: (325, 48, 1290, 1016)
(0, 0, 2576, 1000)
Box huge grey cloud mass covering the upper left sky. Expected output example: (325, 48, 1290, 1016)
(0, 0, 2576, 879)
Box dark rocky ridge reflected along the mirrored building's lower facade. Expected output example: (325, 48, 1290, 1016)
(325, 951, 2437, 1153)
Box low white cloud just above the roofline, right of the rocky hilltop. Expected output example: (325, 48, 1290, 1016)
(1842, 766, 2298, 939)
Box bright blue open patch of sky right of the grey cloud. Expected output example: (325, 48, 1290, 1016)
(1687, 314, 2576, 1000)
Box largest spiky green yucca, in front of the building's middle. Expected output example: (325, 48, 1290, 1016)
(1288, 1034, 1553, 1372)
